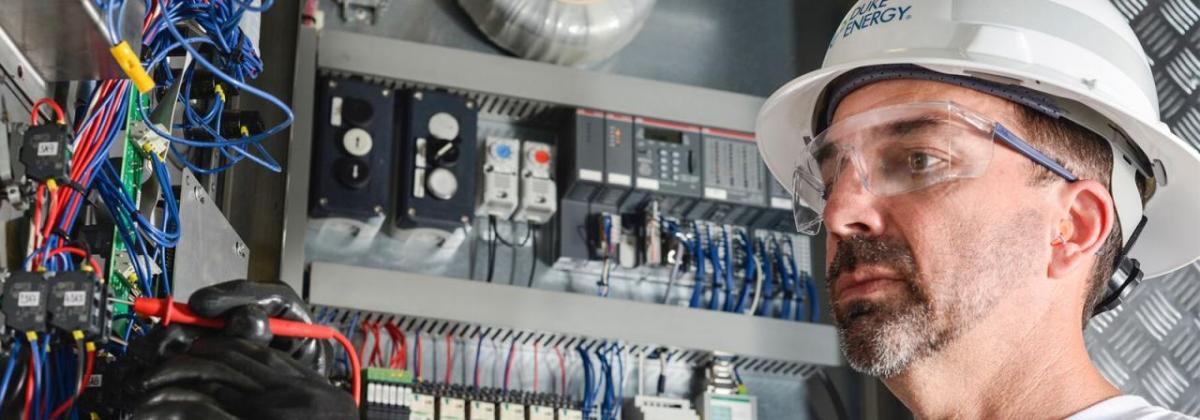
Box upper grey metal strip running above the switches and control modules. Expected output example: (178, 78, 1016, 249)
(317, 30, 764, 132)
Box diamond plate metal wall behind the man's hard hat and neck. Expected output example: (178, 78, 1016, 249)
(1085, 0, 1200, 415)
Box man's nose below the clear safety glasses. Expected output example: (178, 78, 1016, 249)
(823, 162, 883, 239)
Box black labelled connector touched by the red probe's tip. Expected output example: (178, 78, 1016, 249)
(47, 271, 109, 342)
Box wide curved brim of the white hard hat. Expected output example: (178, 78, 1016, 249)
(755, 58, 1200, 277)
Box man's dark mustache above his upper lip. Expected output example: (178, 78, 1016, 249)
(826, 236, 917, 290)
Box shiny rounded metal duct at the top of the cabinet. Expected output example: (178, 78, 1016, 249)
(458, 0, 655, 66)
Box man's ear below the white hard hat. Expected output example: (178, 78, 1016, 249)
(1048, 180, 1117, 278)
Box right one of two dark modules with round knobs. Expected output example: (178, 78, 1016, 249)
(395, 90, 479, 230)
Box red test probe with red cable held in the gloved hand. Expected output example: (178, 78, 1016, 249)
(133, 298, 362, 404)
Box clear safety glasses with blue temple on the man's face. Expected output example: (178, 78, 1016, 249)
(792, 102, 1078, 235)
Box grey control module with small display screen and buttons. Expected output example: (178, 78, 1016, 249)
(622, 118, 703, 216)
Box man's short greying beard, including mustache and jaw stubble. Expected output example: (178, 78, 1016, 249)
(827, 210, 1037, 378)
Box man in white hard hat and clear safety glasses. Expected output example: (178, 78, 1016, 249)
(757, 0, 1200, 419)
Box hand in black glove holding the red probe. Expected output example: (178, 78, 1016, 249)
(106, 281, 356, 419)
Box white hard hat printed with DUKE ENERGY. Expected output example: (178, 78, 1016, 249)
(756, 0, 1200, 282)
